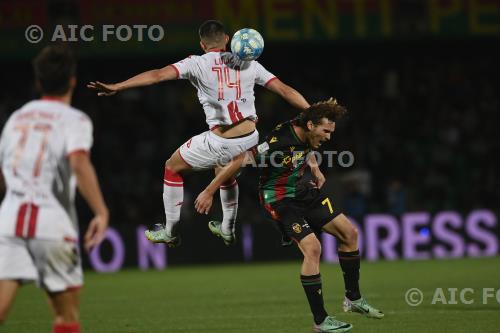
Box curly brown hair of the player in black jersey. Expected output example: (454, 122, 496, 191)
(297, 97, 347, 129)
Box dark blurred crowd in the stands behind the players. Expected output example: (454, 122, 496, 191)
(0, 41, 500, 225)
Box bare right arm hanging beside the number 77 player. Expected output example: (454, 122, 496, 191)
(69, 153, 109, 251)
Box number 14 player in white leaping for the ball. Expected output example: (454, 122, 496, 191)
(88, 20, 309, 247)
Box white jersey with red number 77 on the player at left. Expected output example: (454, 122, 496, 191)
(0, 100, 92, 239)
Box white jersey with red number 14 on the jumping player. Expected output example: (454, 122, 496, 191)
(171, 51, 276, 129)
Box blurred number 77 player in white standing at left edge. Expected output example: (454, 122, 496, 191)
(0, 46, 108, 333)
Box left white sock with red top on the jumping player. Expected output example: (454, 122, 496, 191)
(163, 169, 184, 235)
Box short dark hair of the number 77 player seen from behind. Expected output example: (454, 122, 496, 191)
(33, 45, 76, 96)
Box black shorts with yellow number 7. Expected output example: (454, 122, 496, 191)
(263, 185, 341, 242)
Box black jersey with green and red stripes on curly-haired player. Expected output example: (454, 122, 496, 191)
(256, 120, 311, 204)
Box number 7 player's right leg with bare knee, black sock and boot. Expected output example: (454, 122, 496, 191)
(323, 214, 384, 319)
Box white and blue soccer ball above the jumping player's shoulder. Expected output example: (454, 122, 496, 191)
(231, 28, 264, 61)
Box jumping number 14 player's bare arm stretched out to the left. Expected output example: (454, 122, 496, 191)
(87, 65, 177, 96)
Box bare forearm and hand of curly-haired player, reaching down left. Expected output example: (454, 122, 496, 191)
(194, 153, 246, 214)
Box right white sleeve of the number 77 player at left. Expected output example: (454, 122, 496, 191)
(65, 114, 93, 156)
